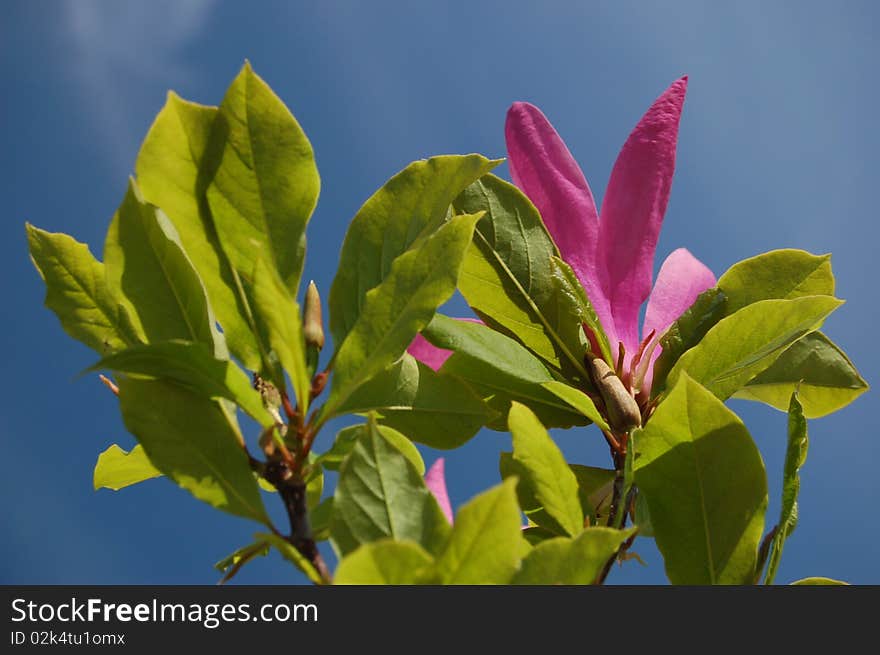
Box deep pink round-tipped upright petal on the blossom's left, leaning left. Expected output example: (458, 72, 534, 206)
(504, 102, 614, 346)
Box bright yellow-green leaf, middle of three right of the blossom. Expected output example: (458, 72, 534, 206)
(669, 296, 843, 400)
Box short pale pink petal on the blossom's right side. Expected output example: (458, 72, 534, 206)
(642, 248, 715, 389)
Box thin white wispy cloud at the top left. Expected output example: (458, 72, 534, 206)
(64, 0, 215, 167)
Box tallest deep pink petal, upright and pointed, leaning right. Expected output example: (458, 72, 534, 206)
(596, 77, 687, 362)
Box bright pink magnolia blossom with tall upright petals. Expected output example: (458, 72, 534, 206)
(410, 77, 715, 392)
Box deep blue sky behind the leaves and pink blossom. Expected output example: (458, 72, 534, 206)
(0, 0, 880, 584)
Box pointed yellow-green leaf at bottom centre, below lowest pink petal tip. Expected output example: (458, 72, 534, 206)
(434, 480, 524, 584)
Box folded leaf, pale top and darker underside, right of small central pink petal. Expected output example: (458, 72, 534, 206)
(422, 314, 586, 431)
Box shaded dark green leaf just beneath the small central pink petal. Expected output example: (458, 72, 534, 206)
(337, 354, 494, 449)
